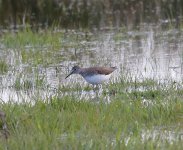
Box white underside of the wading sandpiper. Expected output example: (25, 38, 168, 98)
(85, 74, 111, 84)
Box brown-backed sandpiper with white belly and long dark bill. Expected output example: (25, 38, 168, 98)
(65, 66, 116, 85)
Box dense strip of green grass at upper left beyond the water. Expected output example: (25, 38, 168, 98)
(3, 28, 63, 48)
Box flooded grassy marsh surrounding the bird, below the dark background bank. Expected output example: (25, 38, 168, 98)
(0, 24, 183, 149)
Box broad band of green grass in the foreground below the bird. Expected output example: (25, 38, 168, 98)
(0, 86, 183, 149)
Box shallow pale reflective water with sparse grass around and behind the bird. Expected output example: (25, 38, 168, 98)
(0, 26, 183, 102)
